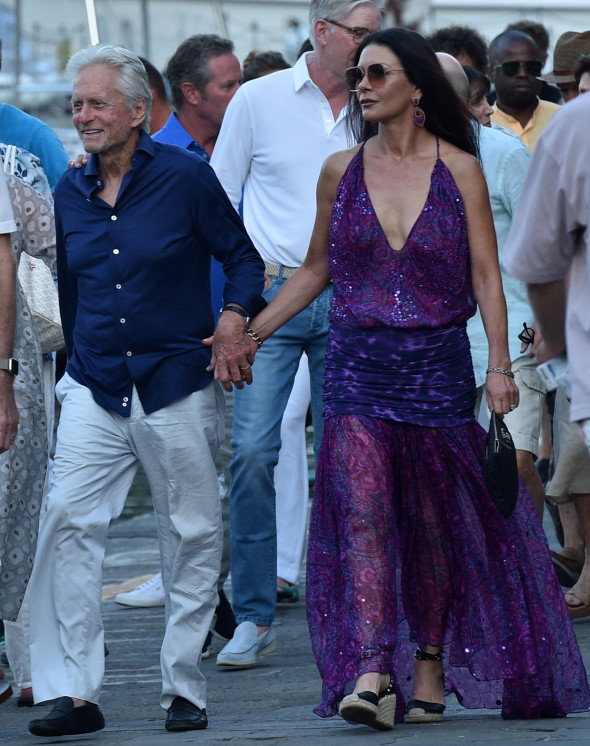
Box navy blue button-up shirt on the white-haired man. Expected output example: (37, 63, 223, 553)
(55, 132, 265, 416)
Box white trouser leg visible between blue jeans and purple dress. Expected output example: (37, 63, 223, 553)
(274, 354, 311, 583)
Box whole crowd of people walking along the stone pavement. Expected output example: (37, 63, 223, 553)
(0, 0, 590, 737)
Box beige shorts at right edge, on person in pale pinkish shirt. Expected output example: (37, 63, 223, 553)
(545, 386, 590, 503)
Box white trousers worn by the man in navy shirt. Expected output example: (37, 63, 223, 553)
(30, 374, 223, 709)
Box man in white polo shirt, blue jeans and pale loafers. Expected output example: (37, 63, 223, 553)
(211, 0, 385, 667)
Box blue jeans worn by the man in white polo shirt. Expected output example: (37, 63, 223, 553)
(230, 278, 332, 626)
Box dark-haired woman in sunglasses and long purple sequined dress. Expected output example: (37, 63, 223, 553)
(219, 29, 590, 729)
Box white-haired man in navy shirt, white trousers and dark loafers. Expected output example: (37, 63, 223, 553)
(29, 45, 264, 736)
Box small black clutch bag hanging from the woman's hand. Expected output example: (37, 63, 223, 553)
(482, 412, 519, 518)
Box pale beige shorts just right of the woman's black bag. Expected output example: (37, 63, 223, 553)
(476, 356, 546, 457)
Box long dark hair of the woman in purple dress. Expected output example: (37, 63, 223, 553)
(348, 28, 479, 157)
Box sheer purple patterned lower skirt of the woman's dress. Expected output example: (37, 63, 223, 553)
(307, 326, 590, 720)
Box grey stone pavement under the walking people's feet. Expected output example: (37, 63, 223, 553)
(0, 514, 590, 746)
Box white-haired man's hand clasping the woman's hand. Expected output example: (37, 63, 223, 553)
(203, 311, 256, 391)
